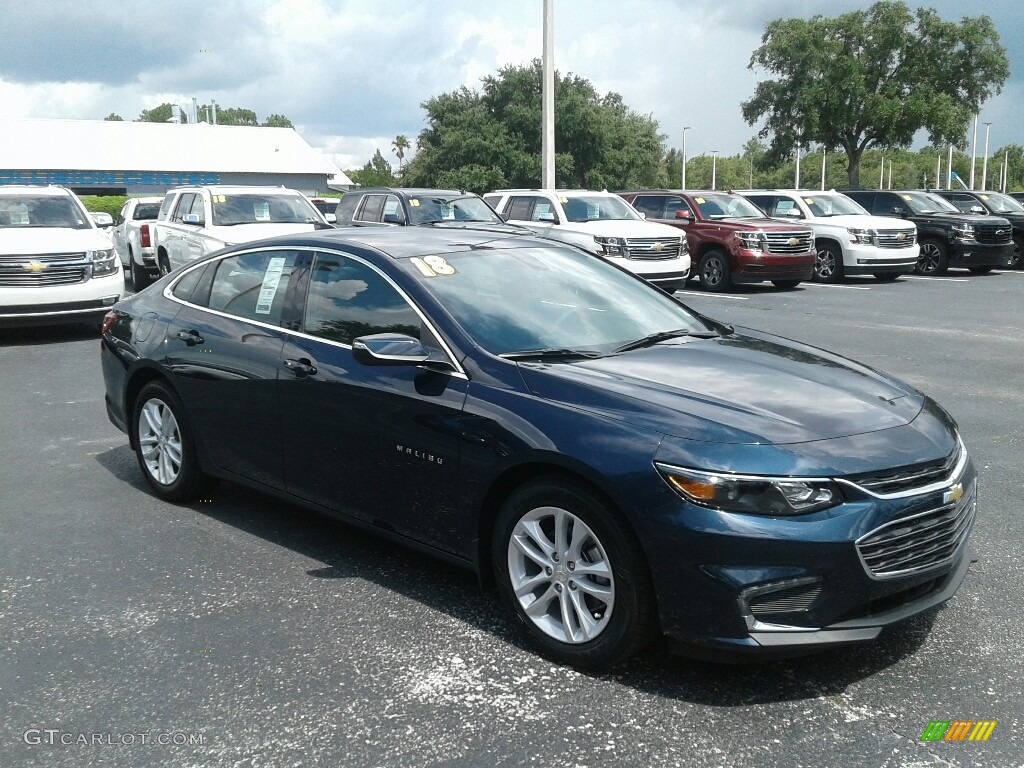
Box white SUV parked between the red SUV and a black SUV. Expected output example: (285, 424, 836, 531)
(738, 189, 920, 283)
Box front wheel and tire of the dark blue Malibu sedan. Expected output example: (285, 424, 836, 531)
(492, 477, 656, 667)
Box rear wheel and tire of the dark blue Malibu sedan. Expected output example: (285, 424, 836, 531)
(131, 381, 211, 502)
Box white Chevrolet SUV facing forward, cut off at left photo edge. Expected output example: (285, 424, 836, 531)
(0, 185, 125, 326)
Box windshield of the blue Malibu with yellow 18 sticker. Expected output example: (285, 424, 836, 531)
(404, 243, 708, 354)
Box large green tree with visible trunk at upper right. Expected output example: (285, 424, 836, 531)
(742, 0, 1010, 187)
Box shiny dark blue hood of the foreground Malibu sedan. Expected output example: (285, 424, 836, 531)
(520, 329, 924, 444)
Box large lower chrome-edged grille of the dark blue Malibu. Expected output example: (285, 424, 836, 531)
(857, 484, 978, 579)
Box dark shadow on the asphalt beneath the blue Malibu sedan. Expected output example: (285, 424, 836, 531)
(95, 444, 938, 707)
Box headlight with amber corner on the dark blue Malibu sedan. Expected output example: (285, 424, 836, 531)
(655, 464, 845, 516)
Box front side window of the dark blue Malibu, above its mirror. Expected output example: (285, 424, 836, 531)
(303, 254, 422, 344)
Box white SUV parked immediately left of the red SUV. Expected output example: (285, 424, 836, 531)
(483, 189, 690, 293)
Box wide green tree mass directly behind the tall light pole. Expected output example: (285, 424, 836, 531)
(403, 60, 665, 193)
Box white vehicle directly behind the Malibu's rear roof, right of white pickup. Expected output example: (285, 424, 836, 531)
(154, 185, 334, 274)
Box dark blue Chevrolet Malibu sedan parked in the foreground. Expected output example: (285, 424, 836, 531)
(100, 227, 977, 666)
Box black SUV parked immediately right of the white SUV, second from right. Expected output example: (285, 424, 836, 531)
(844, 189, 1014, 274)
